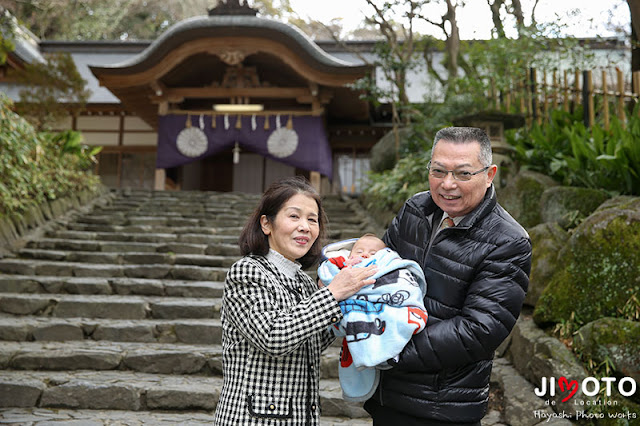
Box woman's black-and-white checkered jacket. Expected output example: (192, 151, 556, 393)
(215, 256, 342, 426)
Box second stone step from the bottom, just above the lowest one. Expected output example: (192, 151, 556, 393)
(0, 370, 367, 418)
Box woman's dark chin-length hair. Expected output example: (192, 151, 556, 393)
(239, 176, 327, 269)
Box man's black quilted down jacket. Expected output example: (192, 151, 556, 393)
(373, 186, 531, 423)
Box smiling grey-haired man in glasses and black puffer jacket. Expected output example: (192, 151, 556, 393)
(365, 127, 531, 426)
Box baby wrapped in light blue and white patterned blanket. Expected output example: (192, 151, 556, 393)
(318, 234, 427, 401)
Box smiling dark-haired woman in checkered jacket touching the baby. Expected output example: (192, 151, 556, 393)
(215, 178, 376, 425)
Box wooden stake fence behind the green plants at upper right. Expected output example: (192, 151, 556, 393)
(489, 68, 640, 129)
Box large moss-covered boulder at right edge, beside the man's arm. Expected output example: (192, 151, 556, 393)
(534, 200, 640, 325)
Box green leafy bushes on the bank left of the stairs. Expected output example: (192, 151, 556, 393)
(0, 95, 100, 216)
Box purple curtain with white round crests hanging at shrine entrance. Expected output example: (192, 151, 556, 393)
(156, 114, 332, 177)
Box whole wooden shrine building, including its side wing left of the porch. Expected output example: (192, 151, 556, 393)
(3, 0, 389, 194)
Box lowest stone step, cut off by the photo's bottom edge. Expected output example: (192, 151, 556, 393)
(0, 408, 373, 426)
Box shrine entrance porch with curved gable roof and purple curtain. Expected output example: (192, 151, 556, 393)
(91, 0, 377, 192)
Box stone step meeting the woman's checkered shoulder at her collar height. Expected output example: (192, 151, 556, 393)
(0, 258, 228, 281)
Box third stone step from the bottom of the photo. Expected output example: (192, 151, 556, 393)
(0, 340, 340, 379)
